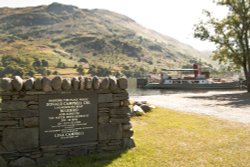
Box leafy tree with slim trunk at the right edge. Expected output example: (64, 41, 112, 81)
(194, 0, 250, 92)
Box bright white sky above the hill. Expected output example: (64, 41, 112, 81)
(0, 0, 226, 51)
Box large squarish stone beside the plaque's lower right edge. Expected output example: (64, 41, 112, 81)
(99, 123, 122, 140)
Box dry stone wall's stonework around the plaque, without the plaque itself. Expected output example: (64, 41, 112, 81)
(0, 76, 135, 167)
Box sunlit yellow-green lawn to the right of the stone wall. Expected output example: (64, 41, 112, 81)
(44, 109, 250, 167)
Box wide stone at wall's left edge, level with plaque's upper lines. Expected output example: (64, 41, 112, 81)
(2, 101, 27, 111)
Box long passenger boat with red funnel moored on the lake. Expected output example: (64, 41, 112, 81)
(143, 64, 241, 90)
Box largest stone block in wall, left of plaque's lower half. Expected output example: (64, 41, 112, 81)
(2, 128, 39, 151)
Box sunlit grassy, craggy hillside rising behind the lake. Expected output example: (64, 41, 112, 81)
(0, 3, 212, 76)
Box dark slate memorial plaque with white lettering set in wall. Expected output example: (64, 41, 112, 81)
(39, 93, 97, 145)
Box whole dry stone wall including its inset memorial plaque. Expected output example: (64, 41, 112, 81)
(0, 76, 135, 167)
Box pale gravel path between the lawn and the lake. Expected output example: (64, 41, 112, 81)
(131, 91, 250, 124)
